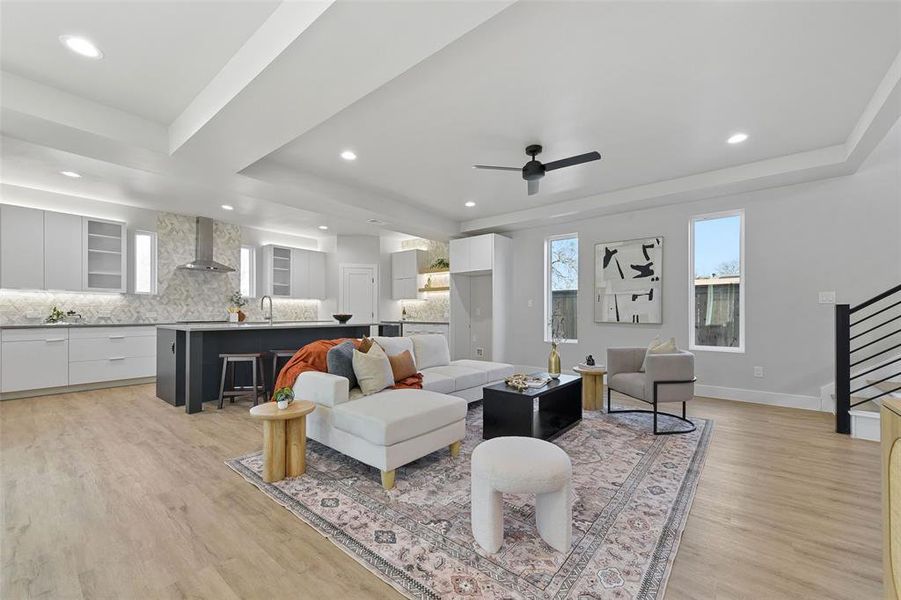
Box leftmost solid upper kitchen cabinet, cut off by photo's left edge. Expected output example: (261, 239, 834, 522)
(0, 204, 44, 290)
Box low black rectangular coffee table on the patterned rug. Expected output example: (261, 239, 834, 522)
(482, 373, 582, 440)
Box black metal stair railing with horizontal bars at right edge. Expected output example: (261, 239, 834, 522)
(835, 284, 901, 433)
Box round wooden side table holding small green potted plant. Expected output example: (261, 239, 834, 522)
(250, 400, 316, 483)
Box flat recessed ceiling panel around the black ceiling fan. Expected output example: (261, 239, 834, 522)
(266, 2, 901, 220)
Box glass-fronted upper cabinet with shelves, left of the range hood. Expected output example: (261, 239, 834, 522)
(82, 217, 126, 292)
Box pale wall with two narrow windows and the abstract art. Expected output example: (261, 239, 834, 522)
(508, 124, 901, 408)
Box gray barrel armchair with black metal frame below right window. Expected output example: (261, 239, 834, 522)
(607, 348, 695, 435)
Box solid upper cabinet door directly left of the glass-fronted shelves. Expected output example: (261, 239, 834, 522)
(44, 211, 84, 292)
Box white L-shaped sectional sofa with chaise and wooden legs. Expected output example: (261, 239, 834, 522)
(294, 335, 513, 489)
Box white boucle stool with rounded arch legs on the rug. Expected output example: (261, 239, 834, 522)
(471, 436, 572, 553)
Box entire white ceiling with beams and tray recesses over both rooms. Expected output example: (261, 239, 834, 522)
(0, 0, 901, 238)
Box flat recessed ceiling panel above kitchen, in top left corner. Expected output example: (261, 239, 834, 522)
(0, 0, 279, 125)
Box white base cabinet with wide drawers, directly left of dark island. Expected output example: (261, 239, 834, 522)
(69, 327, 156, 385)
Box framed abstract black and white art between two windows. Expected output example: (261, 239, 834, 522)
(594, 236, 663, 323)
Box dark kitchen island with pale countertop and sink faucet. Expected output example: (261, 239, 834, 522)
(156, 321, 372, 414)
